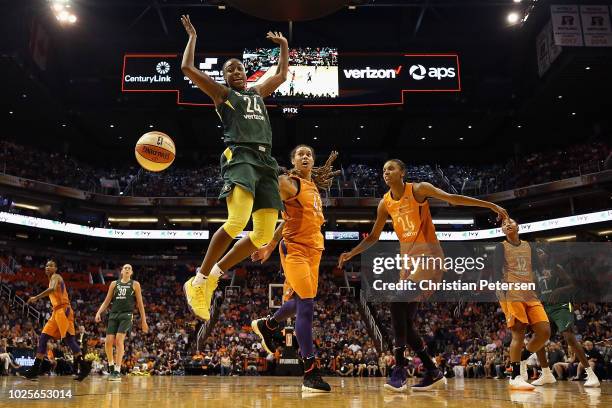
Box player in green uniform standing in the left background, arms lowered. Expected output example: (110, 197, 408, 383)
(96, 264, 149, 381)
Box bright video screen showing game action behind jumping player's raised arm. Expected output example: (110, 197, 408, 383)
(242, 47, 339, 99)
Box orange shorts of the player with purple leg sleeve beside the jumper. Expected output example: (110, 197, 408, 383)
(279, 240, 323, 301)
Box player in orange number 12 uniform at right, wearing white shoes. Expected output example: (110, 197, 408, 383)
(494, 218, 550, 390)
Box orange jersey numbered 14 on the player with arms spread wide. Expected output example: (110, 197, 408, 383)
(383, 183, 438, 244)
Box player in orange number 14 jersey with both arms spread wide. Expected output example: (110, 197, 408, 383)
(338, 159, 508, 392)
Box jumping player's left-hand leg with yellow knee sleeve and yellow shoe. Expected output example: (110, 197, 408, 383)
(183, 184, 253, 320)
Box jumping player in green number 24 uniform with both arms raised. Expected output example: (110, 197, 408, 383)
(181, 16, 289, 320)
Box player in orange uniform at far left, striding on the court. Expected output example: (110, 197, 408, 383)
(24, 259, 91, 381)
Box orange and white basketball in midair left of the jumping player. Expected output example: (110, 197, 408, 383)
(134, 131, 176, 172)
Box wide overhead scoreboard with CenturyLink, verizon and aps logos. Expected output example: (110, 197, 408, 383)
(121, 47, 461, 108)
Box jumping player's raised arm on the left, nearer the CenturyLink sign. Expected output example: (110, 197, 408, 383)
(181, 15, 229, 105)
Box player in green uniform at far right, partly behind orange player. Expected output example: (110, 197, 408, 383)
(531, 248, 600, 387)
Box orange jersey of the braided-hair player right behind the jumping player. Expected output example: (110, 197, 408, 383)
(283, 176, 325, 250)
